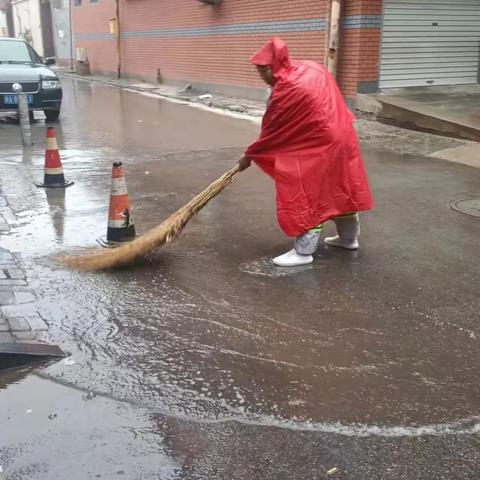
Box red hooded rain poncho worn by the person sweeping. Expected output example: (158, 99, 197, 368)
(245, 38, 373, 237)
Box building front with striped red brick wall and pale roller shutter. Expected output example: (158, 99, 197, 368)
(71, 0, 480, 100)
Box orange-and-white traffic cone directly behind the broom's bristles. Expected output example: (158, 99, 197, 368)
(97, 162, 135, 248)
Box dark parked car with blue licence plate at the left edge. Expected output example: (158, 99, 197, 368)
(0, 38, 62, 121)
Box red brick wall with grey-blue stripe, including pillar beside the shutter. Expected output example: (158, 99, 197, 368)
(73, 0, 381, 97)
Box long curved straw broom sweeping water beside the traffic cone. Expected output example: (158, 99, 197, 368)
(59, 165, 240, 271)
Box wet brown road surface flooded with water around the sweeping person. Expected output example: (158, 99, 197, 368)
(0, 81, 480, 480)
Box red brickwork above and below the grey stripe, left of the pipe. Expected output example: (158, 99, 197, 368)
(73, 0, 327, 91)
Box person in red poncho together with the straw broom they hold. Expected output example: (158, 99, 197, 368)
(59, 38, 373, 271)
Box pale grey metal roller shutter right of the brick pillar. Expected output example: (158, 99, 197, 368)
(380, 0, 480, 88)
